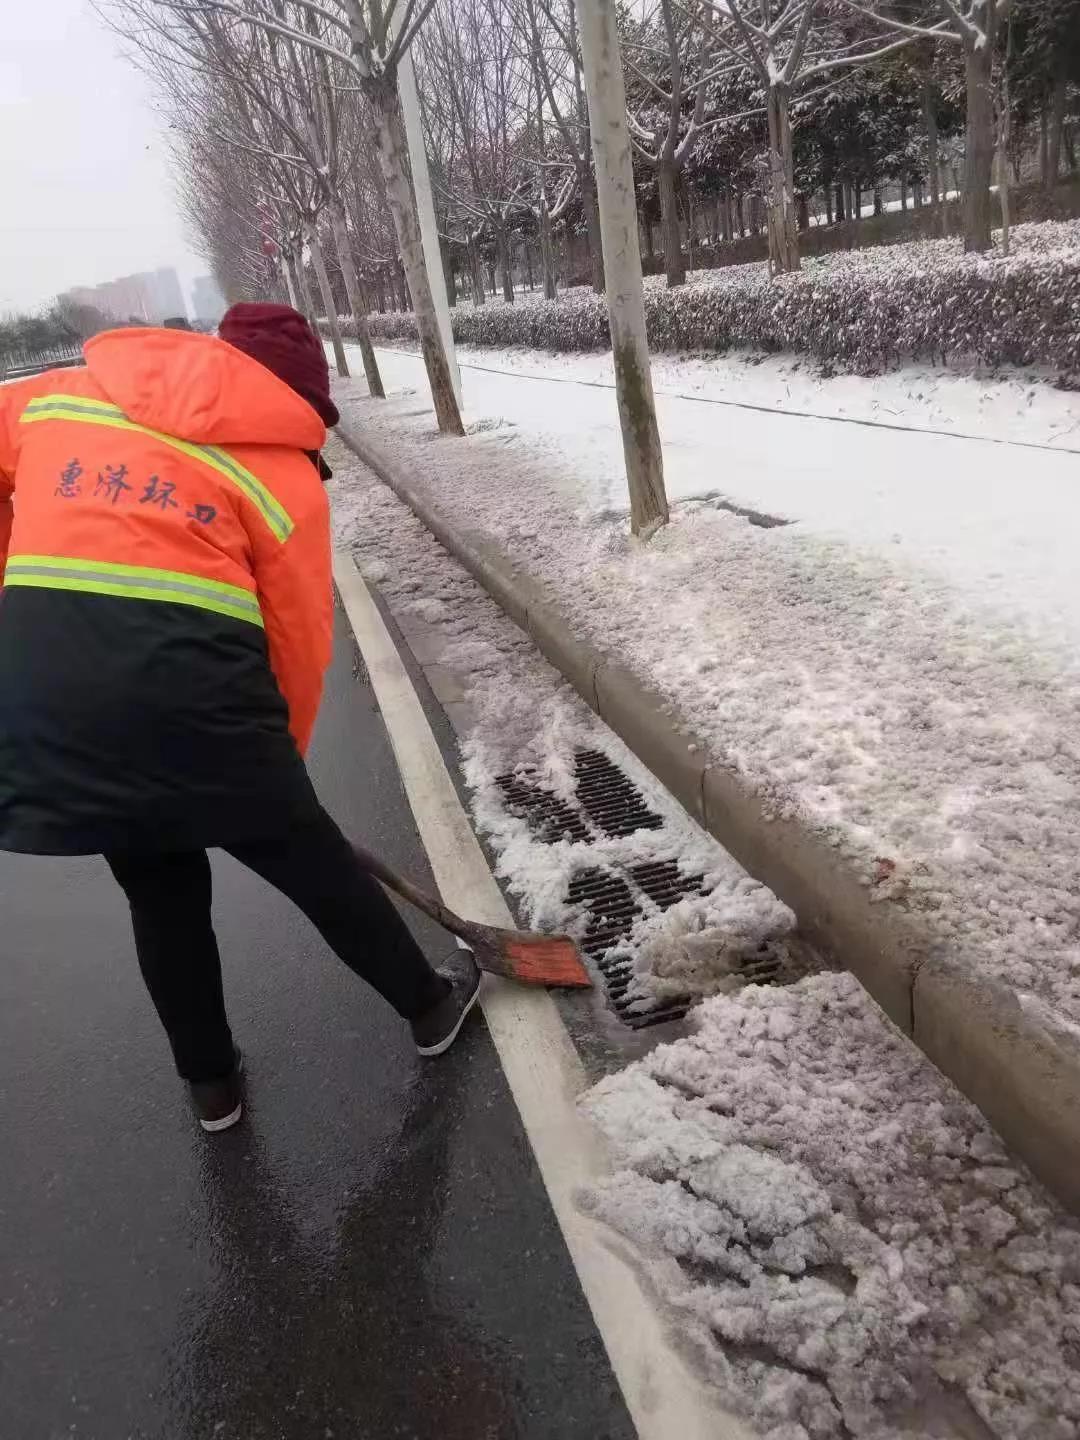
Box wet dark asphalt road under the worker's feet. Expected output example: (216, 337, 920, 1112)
(0, 604, 634, 1440)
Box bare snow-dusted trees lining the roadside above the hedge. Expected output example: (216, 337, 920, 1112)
(108, 0, 1080, 526)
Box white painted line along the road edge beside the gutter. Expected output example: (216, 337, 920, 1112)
(334, 552, 753, 1440)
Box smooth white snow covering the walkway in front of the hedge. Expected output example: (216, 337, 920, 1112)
(360, 348, 1080, 639)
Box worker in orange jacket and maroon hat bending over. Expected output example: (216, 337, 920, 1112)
(0, 305, 480, 1130)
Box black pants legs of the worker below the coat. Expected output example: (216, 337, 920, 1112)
(105, 811, 446, 1080)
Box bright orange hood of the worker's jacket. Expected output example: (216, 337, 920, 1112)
(84, 328, 327, 451)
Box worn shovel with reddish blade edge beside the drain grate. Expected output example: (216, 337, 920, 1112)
(353, 844, 592, 989)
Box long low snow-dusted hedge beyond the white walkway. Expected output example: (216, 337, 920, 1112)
(329, 220, 1080, 374)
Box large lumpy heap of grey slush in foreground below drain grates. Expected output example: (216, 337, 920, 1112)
(585, 975, 1080, 1440)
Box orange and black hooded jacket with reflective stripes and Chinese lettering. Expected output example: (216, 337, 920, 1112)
(0, 328, 333, 852)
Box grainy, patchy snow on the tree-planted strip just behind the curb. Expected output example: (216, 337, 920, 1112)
(329, 372, 1080, 1021)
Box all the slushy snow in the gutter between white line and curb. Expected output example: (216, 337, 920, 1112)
(331, 437, 1080, 1440)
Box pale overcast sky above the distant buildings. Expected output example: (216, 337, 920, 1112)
(0, 0, 207, 314)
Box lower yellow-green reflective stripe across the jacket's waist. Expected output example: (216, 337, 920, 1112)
(4, 554, 262, 628)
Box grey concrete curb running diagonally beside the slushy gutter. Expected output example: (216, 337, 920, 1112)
(337, 423, 1080, 1214)
